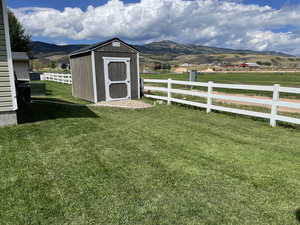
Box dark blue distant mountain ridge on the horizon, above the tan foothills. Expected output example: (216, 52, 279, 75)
(31, 41, 292, 57)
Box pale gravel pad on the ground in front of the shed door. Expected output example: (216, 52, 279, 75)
(92, 100, 153, 109)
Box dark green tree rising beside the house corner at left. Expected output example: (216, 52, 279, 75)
(8, 10, 31, 53)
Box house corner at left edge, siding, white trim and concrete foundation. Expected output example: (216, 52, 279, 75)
(0, 0, 17, 126)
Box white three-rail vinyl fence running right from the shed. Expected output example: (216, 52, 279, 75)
(144, 79, 300, 127)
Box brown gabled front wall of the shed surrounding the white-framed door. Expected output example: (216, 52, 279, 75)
(95, 43, 139, 101)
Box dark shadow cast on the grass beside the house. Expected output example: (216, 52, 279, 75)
(18, 99, 98, 124)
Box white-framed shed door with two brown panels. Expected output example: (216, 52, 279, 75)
(103, 57, 131, 101)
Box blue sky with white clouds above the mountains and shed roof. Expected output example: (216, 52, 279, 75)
(7, 0, 300, 55)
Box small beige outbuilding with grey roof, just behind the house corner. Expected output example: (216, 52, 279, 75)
(12, 52, 30, 81)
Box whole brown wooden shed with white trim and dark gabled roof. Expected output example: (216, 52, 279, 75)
(70, 38, 140, 103)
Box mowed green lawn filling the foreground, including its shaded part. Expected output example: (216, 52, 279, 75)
(0, 83, 300, 225)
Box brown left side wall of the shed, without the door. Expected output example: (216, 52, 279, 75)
(71, 53, 94, 102)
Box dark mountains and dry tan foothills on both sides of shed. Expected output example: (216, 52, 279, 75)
(32, 41, 300, 71)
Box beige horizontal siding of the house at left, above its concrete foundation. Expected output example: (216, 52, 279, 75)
(0, 1, 14, 112)
